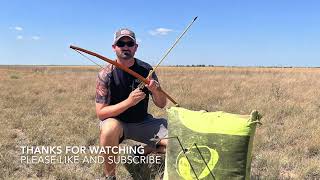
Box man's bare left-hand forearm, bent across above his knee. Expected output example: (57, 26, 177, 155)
(96, 99, 131, 120)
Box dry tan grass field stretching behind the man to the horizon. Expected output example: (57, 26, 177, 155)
(0, 66, 320, 179)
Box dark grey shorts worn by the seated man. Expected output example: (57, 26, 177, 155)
(100, 115, 168, 147)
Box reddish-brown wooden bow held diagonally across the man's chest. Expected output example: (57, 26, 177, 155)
(70, 45, 178, 106)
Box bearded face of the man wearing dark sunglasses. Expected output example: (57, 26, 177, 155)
(112, 37, 138, 60)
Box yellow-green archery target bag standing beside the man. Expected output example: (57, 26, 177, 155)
(164, 107, 261, 180)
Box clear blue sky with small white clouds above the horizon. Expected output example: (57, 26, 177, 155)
(0, 0, 320, 67)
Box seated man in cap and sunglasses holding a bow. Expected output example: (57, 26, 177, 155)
(96, 29, 167, 179)
